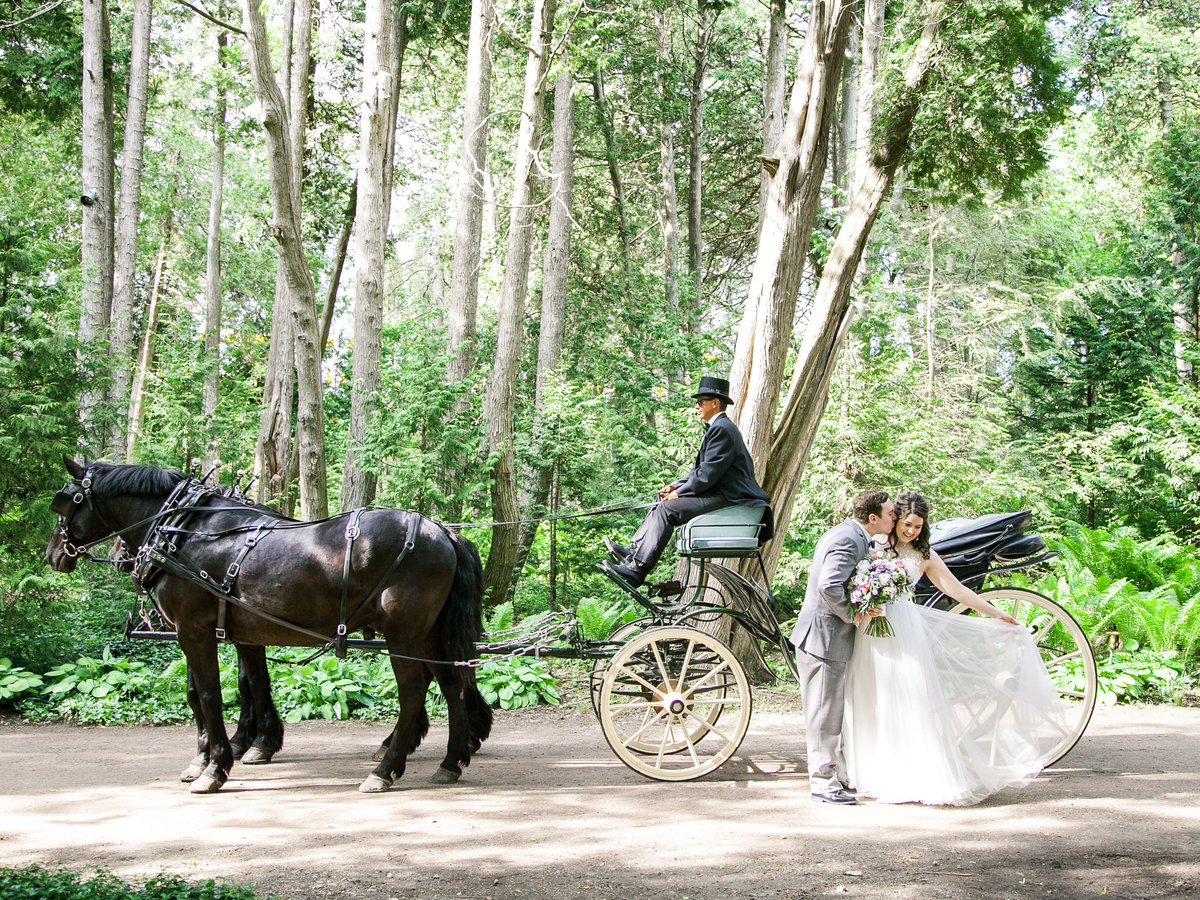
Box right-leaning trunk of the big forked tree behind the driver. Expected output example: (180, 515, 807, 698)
(762, 2, 946, 572)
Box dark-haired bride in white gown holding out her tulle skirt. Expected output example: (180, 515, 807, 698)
(844, 492, 1068, 806)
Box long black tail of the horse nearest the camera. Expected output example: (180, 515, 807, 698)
(438, 530, 492, 750)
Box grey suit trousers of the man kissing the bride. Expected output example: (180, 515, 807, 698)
(796, 649, 850, 793)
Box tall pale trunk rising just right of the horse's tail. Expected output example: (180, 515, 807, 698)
(484, 0, 557, 604)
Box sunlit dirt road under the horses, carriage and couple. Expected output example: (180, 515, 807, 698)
(0, 698, 1200, 900)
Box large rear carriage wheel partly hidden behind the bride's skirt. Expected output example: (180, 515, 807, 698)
(950, 588, 1097, 766)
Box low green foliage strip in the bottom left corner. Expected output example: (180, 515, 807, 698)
(0, 865, 266, 900)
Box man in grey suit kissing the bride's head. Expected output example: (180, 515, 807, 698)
(792, 491, 895, 804)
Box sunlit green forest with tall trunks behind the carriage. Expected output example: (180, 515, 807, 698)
(0, 0, 1200, 713)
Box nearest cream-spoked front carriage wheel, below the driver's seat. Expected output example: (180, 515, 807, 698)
(599, 626, 752, 781)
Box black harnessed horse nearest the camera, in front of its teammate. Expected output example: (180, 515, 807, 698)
(46, 457, 492, 793)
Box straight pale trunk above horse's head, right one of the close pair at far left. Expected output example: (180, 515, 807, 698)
(108, 0, 153, 462)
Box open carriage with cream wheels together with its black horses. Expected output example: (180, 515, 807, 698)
(47, 461, 1096, 792)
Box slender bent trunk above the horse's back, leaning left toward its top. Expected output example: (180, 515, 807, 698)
(242, 0, 329, 518)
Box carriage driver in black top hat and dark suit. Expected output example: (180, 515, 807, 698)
(601, 376, 774, 588)
